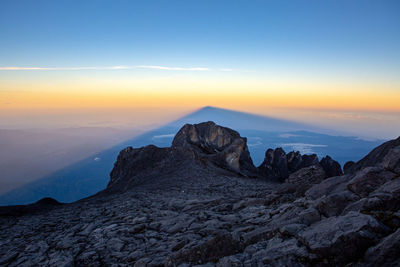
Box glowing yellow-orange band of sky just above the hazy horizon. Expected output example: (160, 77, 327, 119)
(0, 72, 400, 112)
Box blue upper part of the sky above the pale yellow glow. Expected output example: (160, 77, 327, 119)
(0, 1, 400, 74)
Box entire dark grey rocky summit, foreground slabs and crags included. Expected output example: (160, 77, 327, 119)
(0, 122, 400, 266)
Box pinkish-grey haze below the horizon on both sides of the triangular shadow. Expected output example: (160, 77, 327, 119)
(0, 108, 400, 197)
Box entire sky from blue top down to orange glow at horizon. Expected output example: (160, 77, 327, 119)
(0, 0, 400, 136)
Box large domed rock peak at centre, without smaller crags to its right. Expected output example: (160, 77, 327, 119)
(107, 122, 257, 191)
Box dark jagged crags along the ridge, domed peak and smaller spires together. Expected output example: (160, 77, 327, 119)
(108, 122, 342, 191)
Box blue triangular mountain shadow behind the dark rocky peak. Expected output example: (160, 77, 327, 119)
(0, 107, 381, 205)
